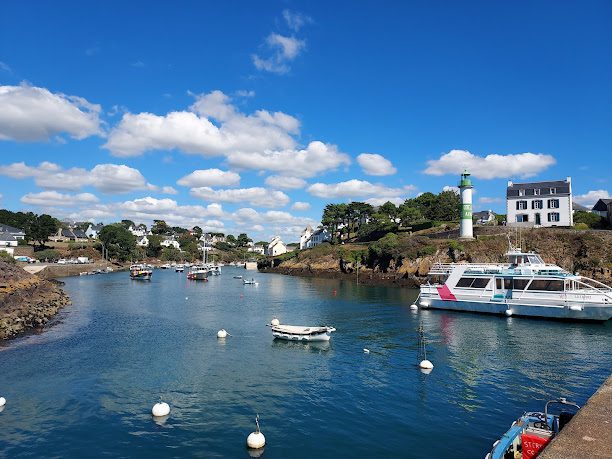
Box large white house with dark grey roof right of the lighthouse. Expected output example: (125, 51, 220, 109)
(506, 177, 574, 227)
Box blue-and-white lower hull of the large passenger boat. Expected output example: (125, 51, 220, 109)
(419, 294, 612, 322)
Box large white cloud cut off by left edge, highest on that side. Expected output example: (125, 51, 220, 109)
(0, 83, 102, 141)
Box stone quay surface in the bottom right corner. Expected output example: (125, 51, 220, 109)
(538, 375, 612, 459)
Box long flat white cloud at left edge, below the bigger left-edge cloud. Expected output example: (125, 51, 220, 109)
(0, 161, 152, 194)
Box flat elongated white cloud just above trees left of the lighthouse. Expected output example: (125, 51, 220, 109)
(308, 179, 415, 201)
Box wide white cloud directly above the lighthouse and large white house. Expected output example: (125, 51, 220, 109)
(424, 150, 556, 179)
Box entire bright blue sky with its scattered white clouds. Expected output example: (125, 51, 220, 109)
(0, 1, 612, 240)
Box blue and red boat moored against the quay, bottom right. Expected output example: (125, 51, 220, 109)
(485, 398, 580, 459)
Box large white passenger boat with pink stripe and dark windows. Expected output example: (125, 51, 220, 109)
(419, 246, 612, 321)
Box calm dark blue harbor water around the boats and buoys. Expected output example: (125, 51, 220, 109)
(0, 267, 612, 458)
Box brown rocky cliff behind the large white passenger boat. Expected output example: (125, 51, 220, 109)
(259, 228, 612, 287)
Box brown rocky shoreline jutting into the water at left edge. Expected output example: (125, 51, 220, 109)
(0, 261, 70, 340)
